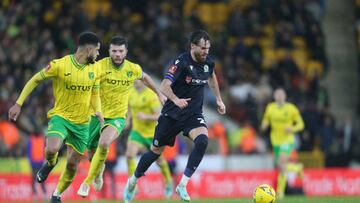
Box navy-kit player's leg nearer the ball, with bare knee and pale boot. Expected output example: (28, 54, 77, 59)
(176, 126, 208, 201)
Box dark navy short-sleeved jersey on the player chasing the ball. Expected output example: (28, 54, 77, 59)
(161, 52, 215, 120)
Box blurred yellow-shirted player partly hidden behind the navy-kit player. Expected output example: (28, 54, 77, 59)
(125, 81, 173, 198)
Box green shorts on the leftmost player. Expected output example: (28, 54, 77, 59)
(46, 116, 89, 154)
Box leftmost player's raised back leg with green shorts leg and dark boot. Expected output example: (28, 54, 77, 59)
(36, 116, 68, 183)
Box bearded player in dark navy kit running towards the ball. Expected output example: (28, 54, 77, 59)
(124, 30, 226, 202)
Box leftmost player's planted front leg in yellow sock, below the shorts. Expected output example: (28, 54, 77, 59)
(51, 145, 82, 203)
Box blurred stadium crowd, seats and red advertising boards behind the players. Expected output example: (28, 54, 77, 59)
(0, 0, 360, 202)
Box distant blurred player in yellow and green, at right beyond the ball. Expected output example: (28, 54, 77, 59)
(261, 88, 304, 198)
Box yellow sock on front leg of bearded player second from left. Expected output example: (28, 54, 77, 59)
(84, 146, 109, 185)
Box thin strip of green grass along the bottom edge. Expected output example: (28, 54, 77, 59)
(68, 196, 360, 203)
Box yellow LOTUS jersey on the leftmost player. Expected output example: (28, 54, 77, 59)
(40, 55, 100, 124)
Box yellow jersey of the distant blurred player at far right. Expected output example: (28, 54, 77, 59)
(262, 102, 304, 145)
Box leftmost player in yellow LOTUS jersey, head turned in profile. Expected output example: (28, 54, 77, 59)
(9, 32, 103, 203)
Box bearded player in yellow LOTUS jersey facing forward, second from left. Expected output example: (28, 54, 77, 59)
(77, 36, 166, 197)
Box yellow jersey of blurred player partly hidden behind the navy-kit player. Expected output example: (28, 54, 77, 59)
(129, 88, 161, 138)
